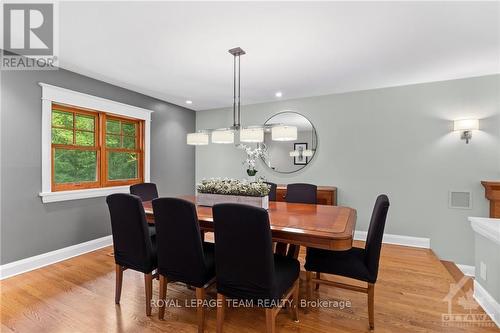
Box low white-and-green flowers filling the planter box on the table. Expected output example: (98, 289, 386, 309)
(196, 178, 270, 197)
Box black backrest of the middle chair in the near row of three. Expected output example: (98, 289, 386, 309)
(153, 198, 206, 287)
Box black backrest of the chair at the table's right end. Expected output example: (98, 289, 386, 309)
(365, 194, 389, 279)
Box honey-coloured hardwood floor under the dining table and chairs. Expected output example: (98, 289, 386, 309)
(0, 243, 499, 333)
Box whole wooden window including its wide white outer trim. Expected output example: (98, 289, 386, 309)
(39, 82, 153, 203)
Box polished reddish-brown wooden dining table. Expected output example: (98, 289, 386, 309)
(143, 196, 356, 251)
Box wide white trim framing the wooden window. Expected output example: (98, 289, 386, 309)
(38, 82, 153, 203)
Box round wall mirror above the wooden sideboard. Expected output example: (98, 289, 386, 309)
(263, 111, 318, 173)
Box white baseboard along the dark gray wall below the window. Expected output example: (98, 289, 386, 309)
(0, 235, 113, 280)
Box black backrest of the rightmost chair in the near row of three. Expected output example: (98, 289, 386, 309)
(213, 204, 275, 300)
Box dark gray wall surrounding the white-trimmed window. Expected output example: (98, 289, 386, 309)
(1, 69, 195, 264)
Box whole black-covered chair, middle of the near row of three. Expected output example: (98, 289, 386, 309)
(153, 198, 215, 332)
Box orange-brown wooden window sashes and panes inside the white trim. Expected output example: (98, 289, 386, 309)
(51, 103, 144, 191)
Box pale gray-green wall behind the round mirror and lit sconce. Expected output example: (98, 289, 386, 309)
(196, 75, 500, 265)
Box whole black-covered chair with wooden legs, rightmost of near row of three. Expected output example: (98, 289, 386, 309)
(212, 204, 300, 333)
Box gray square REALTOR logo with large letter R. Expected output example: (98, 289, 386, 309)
(1, 3, 57, 70)
